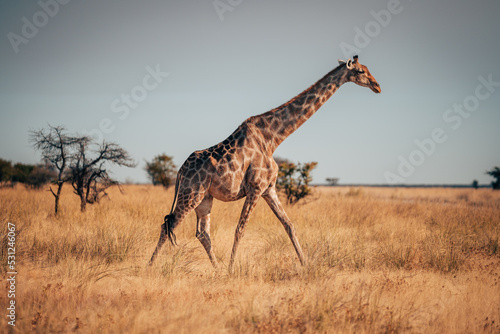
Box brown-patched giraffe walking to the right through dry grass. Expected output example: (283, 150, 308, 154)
(149, 56, 381, 272)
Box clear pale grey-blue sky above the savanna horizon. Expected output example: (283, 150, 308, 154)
(0, 0, 500, 184)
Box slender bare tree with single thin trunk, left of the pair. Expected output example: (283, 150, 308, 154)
(30, 124, 82, 215)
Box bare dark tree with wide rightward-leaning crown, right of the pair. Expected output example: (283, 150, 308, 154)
(69, 137, 135, 212)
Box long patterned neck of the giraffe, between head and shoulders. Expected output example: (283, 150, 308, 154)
(251, 65, 345, 152)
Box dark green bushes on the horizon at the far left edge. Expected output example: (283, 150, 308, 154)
(0, 158, 57, 189)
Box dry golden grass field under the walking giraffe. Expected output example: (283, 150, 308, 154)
(0, 185, 500, 333)
